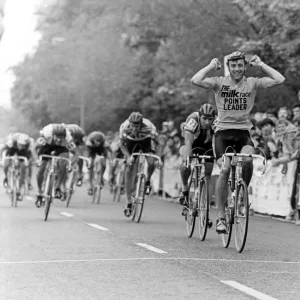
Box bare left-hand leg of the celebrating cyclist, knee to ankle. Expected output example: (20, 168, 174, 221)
(216, 157, 230, 218)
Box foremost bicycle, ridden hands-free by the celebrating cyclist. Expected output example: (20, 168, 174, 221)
(221, 153, 266, 253)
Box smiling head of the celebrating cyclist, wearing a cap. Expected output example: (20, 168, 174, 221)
(226, 51, 247, 80)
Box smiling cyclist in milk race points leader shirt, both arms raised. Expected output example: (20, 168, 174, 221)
(192, 51, 285, 233)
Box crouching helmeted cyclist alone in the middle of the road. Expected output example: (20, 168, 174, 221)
(120, 112, 158, 217)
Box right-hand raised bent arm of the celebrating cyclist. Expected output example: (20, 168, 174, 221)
(249, 55, 285, 87)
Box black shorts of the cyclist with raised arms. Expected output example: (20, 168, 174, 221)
(215, 129, 254, 159)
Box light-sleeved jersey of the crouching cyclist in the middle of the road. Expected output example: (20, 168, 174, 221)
(119, 118, 158, 141)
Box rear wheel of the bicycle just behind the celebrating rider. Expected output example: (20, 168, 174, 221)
(184, 169, 197, 238)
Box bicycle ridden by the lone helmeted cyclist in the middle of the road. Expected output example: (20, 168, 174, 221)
(131, 150, 162, 223)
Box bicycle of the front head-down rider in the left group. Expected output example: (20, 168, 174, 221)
(40, 154, 72, 221)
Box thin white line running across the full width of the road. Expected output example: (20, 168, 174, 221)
(0, 257, 300, 265)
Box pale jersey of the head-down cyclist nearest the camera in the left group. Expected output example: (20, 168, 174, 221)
(37, 124, 76, 150)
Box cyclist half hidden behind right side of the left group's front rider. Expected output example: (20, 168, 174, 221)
(67, 124, 85, 186)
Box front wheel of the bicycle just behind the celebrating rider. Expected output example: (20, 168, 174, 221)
(198, 177, 209, 241)
